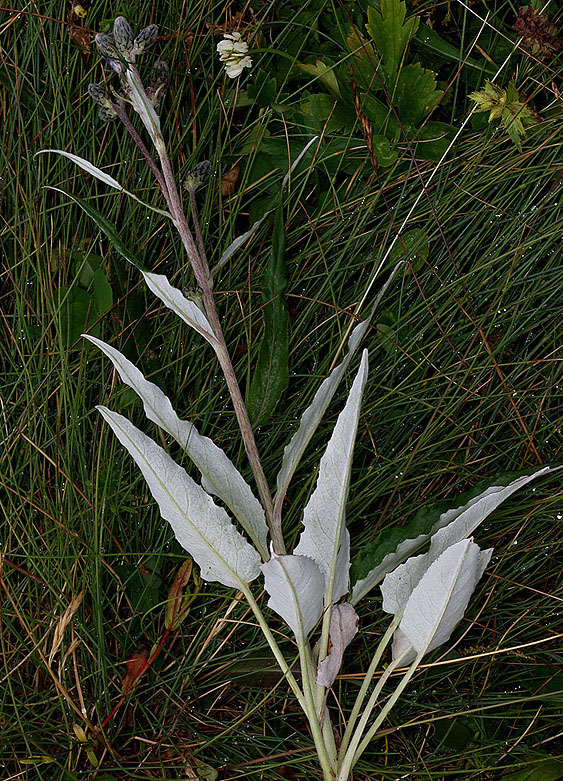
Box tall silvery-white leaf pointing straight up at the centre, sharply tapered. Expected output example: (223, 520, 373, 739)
(294, 350, 368, 606)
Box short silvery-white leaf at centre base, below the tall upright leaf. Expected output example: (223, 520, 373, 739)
(261, 555, 324, 643)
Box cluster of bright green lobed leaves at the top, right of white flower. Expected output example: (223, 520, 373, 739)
(299, 0, 454, 167)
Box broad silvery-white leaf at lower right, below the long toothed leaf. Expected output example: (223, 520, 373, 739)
(395, 539, 492, 664)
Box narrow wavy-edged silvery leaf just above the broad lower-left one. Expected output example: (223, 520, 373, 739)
(82, 334, 268, 559)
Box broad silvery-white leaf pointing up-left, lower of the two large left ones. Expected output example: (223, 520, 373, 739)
(97, 406, 260, 589)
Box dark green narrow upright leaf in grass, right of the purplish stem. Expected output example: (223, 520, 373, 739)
(246, 206, 289, 426)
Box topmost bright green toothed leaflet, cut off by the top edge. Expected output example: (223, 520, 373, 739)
(366, 0, 418, 88)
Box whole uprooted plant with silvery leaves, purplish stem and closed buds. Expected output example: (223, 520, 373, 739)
(38, 17, 553, 781)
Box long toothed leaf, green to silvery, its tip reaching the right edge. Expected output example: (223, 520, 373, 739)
(350, 466, 560, 605)
